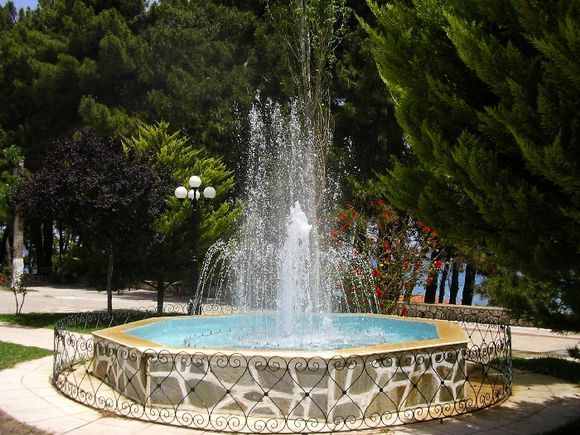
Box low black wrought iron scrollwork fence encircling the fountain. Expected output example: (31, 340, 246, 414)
(53, 305, 512, 433)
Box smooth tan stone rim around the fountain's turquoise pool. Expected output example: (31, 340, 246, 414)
(92, 313, 469, 359)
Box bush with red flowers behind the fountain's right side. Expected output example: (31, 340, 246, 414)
(329, 200, 444, 312)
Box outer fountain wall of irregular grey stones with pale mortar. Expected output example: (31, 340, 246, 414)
(91, 339, 466, 421)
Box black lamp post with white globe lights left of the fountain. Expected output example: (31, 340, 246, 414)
(175, 175, 216, 314)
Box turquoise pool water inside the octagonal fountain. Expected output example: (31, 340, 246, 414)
(125, 314, 439, 350)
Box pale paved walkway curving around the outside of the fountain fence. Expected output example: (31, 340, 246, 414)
(0, 357, 580, 435)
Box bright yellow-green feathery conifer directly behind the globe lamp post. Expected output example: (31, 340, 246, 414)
(123, 122, 240, 281)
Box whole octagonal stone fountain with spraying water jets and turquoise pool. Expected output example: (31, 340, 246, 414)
(81, 102, 478, 432)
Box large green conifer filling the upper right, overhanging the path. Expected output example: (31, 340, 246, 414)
(365, 0, 580, 328)
